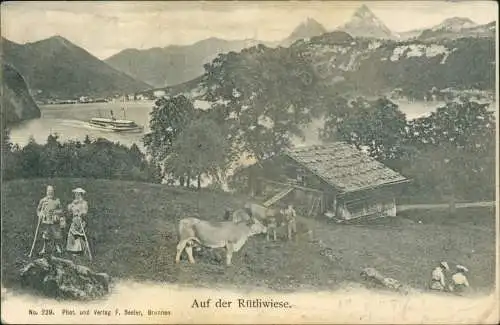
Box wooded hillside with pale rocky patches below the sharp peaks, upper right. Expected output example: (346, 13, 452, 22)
(159, 31, 496, 100)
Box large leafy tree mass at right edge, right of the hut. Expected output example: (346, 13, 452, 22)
(404, 98, 496, 199)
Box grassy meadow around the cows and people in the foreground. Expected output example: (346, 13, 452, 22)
(2, 179, 495, 291)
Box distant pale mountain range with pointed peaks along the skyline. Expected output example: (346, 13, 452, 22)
(105, 5, 495, 88)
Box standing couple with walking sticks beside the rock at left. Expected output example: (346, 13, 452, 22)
(33, 185, 89, 255)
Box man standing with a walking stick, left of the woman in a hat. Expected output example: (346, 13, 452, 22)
(33, 185, 66, 255)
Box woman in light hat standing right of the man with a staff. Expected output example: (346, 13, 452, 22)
(66, 188, 88, 254)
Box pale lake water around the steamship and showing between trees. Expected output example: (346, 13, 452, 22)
(11, 101, 495, 149)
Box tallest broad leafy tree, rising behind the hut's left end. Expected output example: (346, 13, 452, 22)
(203, 45, 318, 159)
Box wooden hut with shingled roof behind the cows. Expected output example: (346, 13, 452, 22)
(236, 142, 409, 220)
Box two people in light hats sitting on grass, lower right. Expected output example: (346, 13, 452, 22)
(430, 261, 469, 293)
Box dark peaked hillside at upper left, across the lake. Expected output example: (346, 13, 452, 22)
(2, 36, 150, 99)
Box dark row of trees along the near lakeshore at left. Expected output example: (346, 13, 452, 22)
(2, 134, 161, 183)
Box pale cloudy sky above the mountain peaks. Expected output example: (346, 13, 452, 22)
(1, 1, 498, 59)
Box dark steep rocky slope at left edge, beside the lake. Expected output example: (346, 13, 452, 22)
(1, 62, 41, 125)
